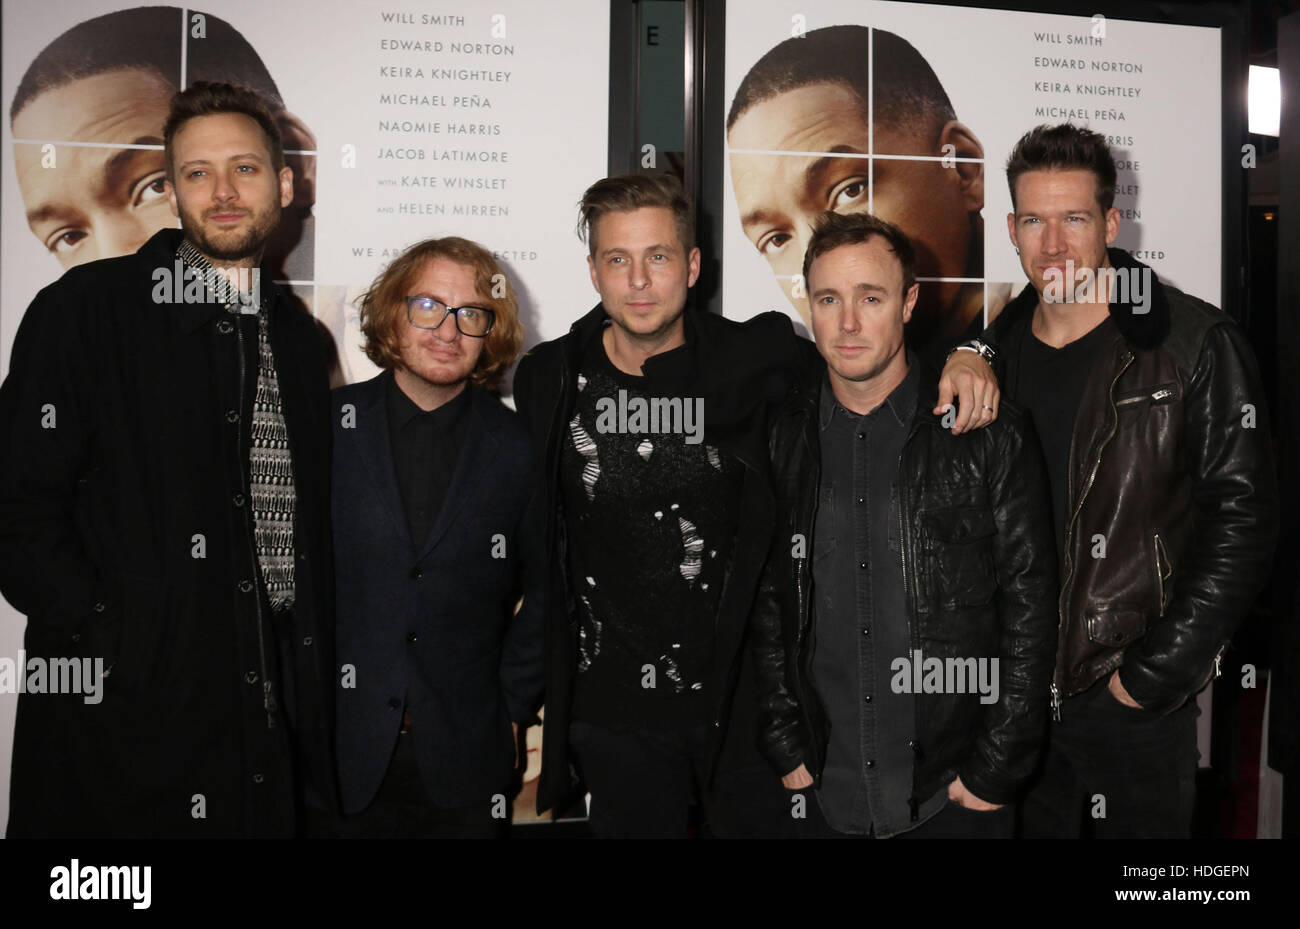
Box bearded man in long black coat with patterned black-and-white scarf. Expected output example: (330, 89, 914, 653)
(0, 82, 337, 837)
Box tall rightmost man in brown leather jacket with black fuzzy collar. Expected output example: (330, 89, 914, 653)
(983, 125, 1278, 837)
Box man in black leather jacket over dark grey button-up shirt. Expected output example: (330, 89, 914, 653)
(753, 213, 1057, 838)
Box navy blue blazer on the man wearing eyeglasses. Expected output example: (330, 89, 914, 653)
(332, 372, 545, 813)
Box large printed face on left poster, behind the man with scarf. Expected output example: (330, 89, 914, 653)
(3, 3, 316, 329)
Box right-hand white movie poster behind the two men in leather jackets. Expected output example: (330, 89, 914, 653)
(723, 0, 1221, 346)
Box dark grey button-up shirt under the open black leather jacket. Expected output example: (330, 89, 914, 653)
(813, 353, 946, 838)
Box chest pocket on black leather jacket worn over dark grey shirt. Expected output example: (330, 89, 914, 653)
(923, 507, 997, 609)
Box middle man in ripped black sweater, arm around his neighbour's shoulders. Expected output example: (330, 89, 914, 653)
(515, 174, 996, 837)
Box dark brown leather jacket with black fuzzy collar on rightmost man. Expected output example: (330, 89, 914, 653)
(983, 248, 1278, 713)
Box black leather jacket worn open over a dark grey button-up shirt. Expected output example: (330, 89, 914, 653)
(753, 363, 1057, 809)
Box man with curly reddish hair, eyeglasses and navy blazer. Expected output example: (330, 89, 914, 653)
(330, 236, 542, 838)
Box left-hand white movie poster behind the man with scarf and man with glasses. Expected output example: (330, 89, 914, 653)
(0, 0, 608, 381)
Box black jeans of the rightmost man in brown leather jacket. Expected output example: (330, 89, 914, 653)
(1021, 674, 1200, 838)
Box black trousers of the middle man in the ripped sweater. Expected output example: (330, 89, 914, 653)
(569, 720, 794, 838)
